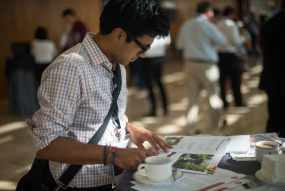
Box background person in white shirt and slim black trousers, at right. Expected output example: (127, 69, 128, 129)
(218, 7, 246, 109)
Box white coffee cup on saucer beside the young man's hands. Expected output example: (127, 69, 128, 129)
(138, 156, 172, 182)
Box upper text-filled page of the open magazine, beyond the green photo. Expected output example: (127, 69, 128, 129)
(163, 135, 231, 155)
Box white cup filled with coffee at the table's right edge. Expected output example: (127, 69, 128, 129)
(255, 141, 279, 162)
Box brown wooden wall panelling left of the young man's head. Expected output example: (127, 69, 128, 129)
(0, 0, 102, 99)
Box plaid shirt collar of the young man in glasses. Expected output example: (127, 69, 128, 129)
(82, 32, 113, 71)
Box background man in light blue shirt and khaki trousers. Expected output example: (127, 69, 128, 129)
(176, 2, 226, 135)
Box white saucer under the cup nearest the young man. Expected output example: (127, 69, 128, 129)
(133, 169, 183, 185)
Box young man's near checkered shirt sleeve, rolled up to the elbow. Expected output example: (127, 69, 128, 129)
(30, 58, 83, 153)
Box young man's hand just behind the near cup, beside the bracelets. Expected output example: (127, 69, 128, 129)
(114, 148, 157, 171)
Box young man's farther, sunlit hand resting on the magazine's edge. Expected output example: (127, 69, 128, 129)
(126, 123, 173, 153)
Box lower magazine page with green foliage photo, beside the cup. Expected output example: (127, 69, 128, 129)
(159, 152, 223, 175)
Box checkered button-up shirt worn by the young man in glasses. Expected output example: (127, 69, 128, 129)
(30, 33, 128, 188)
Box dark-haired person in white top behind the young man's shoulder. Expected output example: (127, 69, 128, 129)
(32, 27, 57, 83)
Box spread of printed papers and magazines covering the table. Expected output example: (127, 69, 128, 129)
(132, 133, 281, 191)
